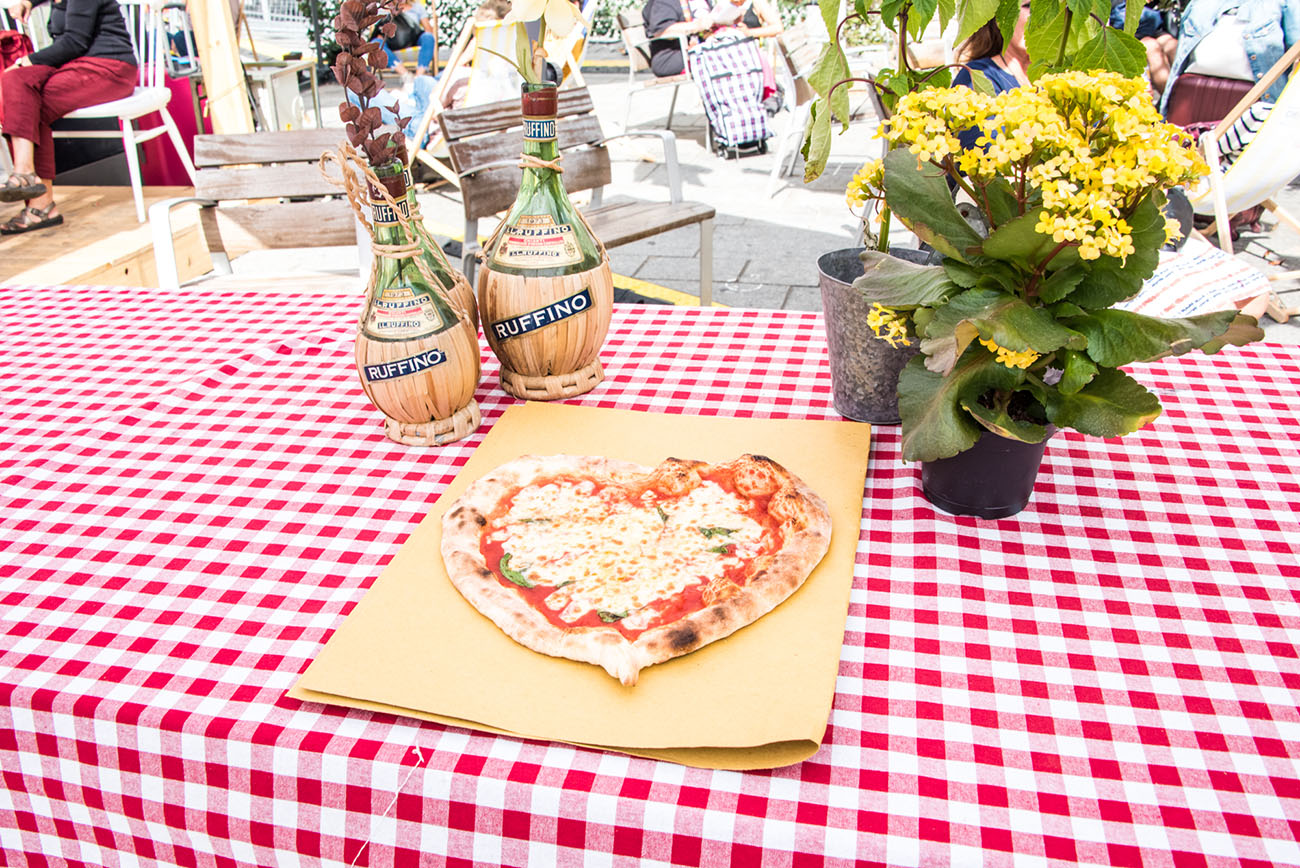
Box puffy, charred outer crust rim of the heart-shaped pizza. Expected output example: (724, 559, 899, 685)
(442, 455, 831, 686)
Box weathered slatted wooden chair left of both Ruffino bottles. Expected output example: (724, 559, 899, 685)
(150, 129, 360, 288)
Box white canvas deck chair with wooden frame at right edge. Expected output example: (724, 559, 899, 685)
(1187, 43, 1300, 279)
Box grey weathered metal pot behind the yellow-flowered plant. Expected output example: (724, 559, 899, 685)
(816, 247, 926, 425)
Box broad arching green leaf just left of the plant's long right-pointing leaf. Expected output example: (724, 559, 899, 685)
(920, 290, 1083, 372)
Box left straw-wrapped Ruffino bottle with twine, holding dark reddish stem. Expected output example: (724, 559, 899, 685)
(356, 162, 481, 446)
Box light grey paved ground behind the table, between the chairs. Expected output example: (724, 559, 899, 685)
(250, 38, 1300, 344)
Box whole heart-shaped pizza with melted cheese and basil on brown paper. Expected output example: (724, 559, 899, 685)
(442, 455, 831, 685)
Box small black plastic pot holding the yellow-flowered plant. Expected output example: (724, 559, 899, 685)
(920, 425, 1056, 518)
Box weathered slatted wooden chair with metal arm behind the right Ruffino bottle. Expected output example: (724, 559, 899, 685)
(438, 88, 715, 305)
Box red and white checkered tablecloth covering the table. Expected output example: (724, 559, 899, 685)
(0, 281, 1300, 867)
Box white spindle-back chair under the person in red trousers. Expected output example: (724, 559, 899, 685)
(55, 0, 194, 223)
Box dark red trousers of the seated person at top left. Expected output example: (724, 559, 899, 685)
(0, 57, 135, 178)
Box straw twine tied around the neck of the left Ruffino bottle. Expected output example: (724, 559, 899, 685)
(320, 144, 478, 331)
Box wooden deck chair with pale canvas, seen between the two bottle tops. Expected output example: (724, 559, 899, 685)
(410, 19, 523, 187)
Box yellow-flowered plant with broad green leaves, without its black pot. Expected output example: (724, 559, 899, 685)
(846, 70, 1262, 461)
